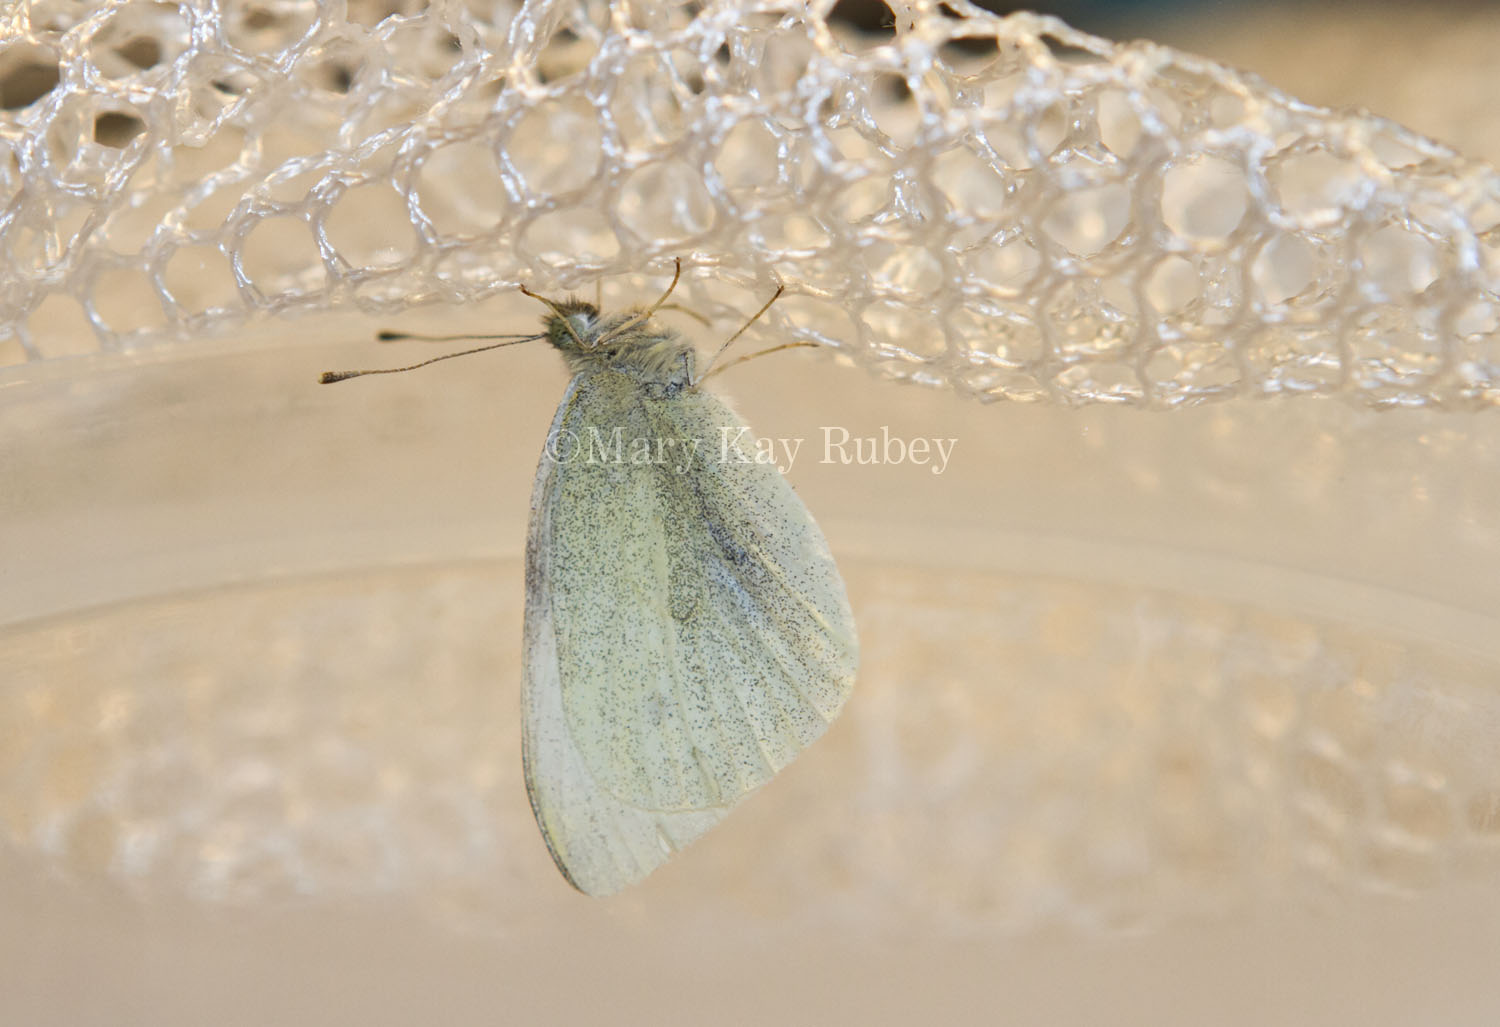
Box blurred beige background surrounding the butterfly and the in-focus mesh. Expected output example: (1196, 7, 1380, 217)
(0, 3, 1500, 1027)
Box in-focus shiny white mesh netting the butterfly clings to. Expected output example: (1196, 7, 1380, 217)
(0, 0, 1500, 405)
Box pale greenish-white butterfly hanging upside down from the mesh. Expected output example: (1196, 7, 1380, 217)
(323, 262, 858, 895)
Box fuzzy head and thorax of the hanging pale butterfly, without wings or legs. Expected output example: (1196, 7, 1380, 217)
(542, 300, 693, 388)
